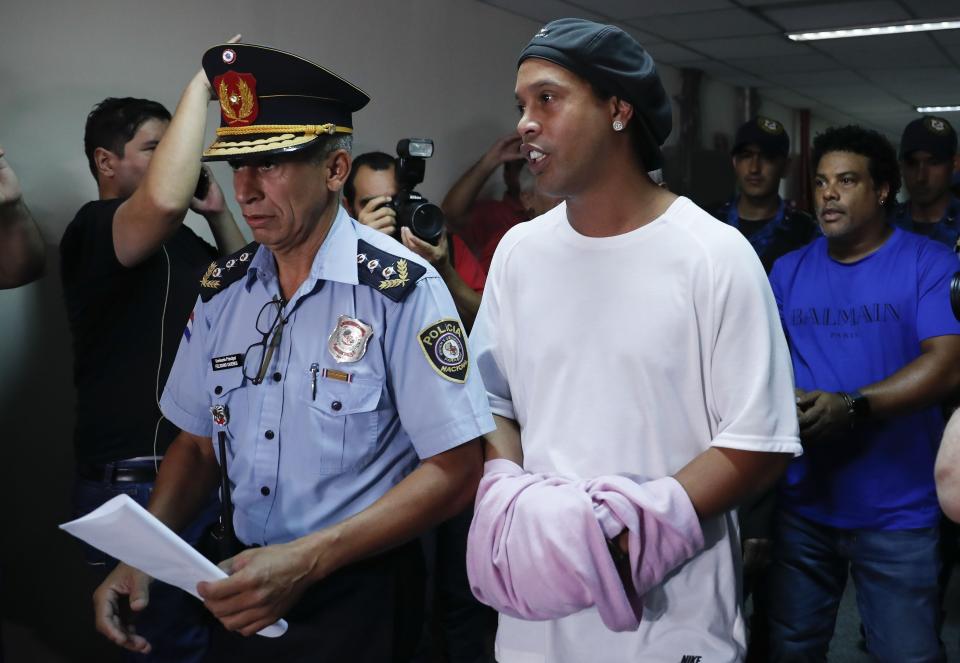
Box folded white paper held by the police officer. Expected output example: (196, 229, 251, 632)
(60, 495, 287, 638)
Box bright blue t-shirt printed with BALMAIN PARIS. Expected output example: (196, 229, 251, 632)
(770, 228, 960, 530)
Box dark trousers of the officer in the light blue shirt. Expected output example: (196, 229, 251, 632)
(207, 541, 425, 663)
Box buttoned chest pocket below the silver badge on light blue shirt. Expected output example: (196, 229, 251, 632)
(300, 371, 383, 474)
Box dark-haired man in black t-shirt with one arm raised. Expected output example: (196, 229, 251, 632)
(60, 75, 244, 662)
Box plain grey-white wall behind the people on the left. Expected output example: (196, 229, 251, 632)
(0, 0, 816, 661)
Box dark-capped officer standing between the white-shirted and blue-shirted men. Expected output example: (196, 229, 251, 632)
(712, 116, 817, 273)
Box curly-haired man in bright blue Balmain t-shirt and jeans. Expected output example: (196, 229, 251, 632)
(770, 127, 960, 662)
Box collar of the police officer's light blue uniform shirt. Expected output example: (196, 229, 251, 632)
(246, 206, 359, 292)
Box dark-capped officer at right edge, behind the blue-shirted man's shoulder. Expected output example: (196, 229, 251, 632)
(890, 115, 960, 249)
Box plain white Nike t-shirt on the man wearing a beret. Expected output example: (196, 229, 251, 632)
(470, 198, 800, 663)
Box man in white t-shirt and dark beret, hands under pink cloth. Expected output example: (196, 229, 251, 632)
(470, 19, 800, 663)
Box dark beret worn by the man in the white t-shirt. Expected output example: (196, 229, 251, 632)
(517, 18, 673, 170)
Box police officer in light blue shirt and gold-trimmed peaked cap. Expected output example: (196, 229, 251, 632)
(95, 44, 494, 662)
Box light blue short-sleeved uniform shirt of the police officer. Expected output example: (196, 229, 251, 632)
(160, 209, 494, 545)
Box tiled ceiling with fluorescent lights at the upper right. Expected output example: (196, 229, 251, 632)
(478, 0, 960, 137)
